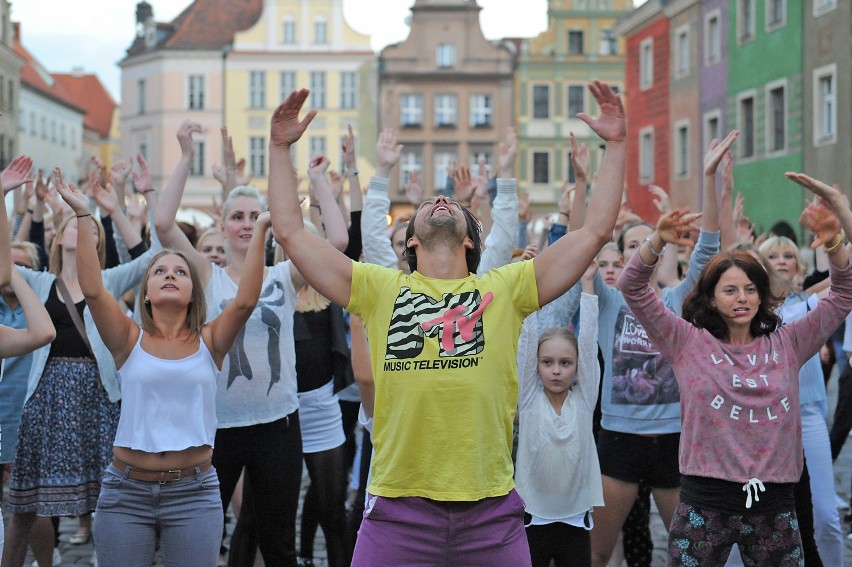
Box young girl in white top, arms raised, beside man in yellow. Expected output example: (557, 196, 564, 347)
(515, 288, 604, 567)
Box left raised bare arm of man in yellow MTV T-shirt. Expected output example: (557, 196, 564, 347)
(269, 89, 352, 307)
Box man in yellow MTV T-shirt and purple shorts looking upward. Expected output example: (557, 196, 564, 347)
(269, 82, 625, 566)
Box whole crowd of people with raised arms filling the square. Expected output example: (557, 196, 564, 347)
(0, 81, 852, 567)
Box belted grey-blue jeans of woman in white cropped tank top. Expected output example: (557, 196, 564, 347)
(94, 465, 225, 567)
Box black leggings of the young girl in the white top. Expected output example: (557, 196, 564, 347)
(526, 522, 592, 567)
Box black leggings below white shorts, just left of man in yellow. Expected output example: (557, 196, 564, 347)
(299, 445, 351, 567)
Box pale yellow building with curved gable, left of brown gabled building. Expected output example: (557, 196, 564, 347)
(223, 0, 376, 193)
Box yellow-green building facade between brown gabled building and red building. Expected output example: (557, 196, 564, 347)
(515, 0, 633, 208)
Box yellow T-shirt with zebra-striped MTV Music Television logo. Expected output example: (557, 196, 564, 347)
(347, 261, 539, 501)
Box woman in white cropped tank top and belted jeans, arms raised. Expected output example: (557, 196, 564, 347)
(57, 176, 270, 567)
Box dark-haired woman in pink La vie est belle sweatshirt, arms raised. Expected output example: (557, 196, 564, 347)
(618, 173, 852, 566)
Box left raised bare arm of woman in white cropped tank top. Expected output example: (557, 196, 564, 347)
(55, 167, 135, 361)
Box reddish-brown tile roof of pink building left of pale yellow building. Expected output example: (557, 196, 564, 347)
(127, 0, 263, 57)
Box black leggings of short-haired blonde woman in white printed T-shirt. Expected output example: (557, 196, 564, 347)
(213, 412, 302, 567)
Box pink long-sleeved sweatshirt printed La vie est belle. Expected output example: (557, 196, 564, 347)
(618, 254, 852, 483)
